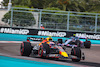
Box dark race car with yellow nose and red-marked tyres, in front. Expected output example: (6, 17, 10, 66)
(20, 37, 85, 62)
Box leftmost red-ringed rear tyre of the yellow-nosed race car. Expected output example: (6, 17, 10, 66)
(20, 42, 32, 56)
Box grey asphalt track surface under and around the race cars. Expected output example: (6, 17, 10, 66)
(0, 43, 100, 67)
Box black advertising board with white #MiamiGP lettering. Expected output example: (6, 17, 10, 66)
(0, 27, 100, 40)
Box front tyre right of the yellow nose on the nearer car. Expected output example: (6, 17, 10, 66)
(71, 47, 81, 62)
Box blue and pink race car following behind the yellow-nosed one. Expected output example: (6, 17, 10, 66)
(58, 37, 91, 48)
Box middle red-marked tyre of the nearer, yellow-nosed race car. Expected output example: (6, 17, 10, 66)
(38, 43, 50, 58)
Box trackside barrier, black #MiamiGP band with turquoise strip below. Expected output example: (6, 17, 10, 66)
(0, 27, 100, 44)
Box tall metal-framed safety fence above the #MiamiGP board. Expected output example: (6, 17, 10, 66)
(2, 7, 100, 33)
